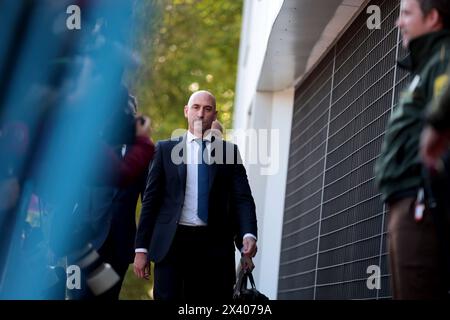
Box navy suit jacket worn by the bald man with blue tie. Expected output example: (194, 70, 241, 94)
(135, 135, 257, 262)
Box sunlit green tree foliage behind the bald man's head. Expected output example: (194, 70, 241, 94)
(130, 0, 242, 140)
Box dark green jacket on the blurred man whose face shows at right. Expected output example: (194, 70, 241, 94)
(375, 30, 450, 201)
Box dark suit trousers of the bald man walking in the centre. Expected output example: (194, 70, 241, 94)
(153, 226, 235, 302)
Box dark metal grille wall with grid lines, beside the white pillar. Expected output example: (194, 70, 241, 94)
(278, 0, 408, 299)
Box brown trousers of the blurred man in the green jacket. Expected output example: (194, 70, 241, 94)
(388, 198, 446, 299)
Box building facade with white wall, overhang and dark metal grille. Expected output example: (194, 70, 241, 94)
(234, 0, 408, 299)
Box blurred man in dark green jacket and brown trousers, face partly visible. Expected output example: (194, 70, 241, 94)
(375, 0, 450, 299)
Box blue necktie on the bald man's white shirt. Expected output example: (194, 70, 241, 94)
(196, 139, 209, 223)
